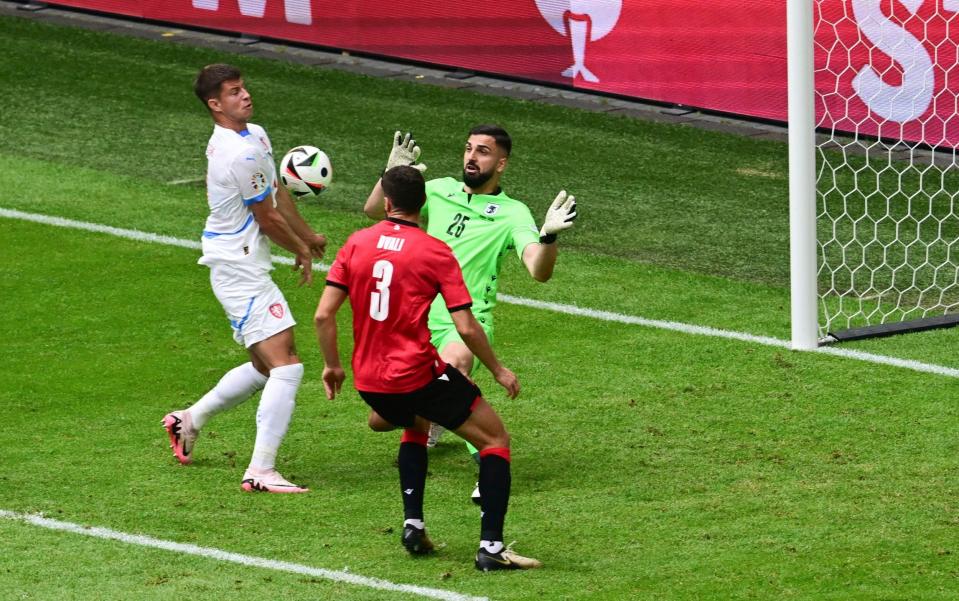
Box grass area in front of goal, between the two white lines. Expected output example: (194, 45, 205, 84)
(0, 213, 959, 601)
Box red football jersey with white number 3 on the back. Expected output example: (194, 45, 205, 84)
(326, 218, 473, 393)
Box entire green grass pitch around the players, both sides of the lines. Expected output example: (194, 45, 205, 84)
(0, 10, 959, 600)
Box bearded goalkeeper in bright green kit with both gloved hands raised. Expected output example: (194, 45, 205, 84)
(363, 125, 576, 501)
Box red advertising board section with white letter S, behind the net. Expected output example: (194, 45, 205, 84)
(815, 0, 959, 147)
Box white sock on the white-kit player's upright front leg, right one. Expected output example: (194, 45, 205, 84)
(250, 363, 303, 473)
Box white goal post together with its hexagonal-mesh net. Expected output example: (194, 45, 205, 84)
(787, 0, 959, 349)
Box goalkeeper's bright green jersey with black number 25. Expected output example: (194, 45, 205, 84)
(422, 177, 539, 331)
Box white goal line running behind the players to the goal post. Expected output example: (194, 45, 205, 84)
(0, 208, 959, 378)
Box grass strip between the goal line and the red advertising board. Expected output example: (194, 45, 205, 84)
(0, 9, 959, 368)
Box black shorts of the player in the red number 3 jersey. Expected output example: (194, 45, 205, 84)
(359, 365, 483, 430)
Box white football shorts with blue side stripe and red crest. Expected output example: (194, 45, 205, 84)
(210, 264, 296, 348)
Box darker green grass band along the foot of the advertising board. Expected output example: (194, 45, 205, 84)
(0, 17, 788, 284)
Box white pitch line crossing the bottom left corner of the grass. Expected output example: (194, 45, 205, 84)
(0, 509, 489, 601)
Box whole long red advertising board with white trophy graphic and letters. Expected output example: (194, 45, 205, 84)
(39, 0, 959, 146)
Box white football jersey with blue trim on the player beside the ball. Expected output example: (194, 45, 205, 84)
(199, 123, 277, 271)
